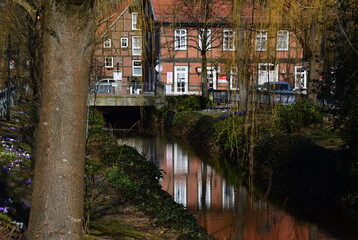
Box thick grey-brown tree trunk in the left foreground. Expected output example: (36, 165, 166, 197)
(26, 0, 95, 240)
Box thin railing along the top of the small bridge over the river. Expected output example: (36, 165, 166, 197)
(89, 82, 155, 96)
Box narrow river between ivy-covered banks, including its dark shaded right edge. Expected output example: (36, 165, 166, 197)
(118, 137, 358, 240)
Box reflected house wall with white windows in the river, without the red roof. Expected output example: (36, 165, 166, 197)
(161, 143, 234, 210)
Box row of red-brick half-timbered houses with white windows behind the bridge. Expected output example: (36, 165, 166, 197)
(92, 0, 307, 95)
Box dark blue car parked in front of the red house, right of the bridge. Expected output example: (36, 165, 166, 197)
(260, 82, 296, 105)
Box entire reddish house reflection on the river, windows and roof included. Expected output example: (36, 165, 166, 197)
(119, 137, 357, 240)
